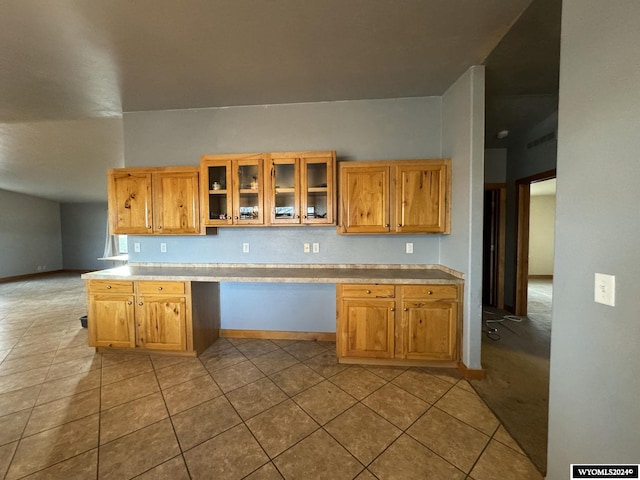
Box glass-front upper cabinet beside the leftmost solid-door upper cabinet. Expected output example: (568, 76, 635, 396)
(200, 154, 265, 227)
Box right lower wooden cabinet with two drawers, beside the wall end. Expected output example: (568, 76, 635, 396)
(336, 284, 461, 364)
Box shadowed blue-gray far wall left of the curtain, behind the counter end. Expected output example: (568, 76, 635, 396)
(60, 202, 112, 270)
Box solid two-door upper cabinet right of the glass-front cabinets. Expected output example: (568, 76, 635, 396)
(338, 159, 451, 234)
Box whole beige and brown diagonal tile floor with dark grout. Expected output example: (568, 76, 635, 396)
(0, 274, 541, 480)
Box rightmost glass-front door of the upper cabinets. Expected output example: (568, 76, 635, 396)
(301, 157, 335, 224)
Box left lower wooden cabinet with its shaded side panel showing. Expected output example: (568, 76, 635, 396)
(87, 280, 220, 355)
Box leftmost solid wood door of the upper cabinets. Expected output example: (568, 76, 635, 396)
(108, 171, 153, 235)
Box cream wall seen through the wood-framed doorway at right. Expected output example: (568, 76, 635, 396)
(529, 195, 556, 275)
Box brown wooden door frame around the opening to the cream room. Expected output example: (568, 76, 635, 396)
(514, 168, 556, 316)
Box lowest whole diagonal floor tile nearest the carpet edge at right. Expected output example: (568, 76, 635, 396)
(407, 407, 489, 473)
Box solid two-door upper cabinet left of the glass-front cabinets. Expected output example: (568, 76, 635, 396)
(108, 167, 201, 235)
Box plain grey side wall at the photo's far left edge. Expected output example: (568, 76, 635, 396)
(0, 190, 62, 278)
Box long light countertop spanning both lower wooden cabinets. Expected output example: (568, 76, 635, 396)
(82, 264, 464, 284)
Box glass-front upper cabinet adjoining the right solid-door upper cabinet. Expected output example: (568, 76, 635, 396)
(266, 151, 336, 225)
